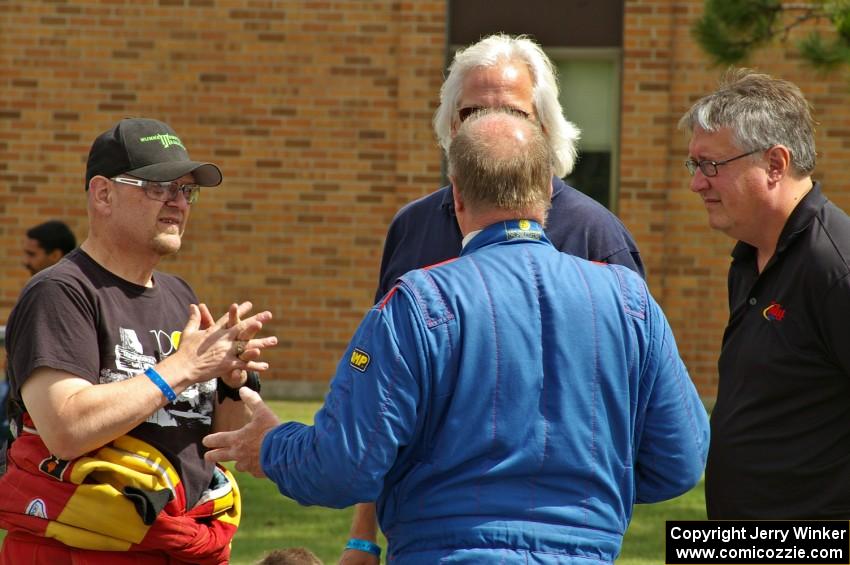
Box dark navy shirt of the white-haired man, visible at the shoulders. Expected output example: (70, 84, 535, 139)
(375, 177, 645, 302)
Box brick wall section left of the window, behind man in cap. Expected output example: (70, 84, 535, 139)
(0, 0, 445, 390)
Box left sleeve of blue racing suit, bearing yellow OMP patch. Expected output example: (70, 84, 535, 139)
(260, 286, 427, 508)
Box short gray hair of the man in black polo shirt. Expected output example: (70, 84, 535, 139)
(679, 69, 815, 176)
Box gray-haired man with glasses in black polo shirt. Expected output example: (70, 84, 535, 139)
(679, 69, 850, 520)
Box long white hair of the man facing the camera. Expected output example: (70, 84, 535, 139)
(433, 34, 579, 177)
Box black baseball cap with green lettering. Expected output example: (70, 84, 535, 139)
(86, 118, 221, 190)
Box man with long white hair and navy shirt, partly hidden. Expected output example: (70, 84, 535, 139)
(343, 34, 644, 565)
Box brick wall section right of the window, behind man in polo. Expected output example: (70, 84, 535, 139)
(620, 0, 850, 397)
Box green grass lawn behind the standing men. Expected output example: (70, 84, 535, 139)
(0, 401, 705, 565)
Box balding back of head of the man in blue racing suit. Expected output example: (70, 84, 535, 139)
(449, 109, 552, 216)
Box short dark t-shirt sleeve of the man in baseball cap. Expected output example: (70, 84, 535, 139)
(7, 278, 100, 398)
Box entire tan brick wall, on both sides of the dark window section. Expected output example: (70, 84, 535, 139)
(0, 0, 850, 398)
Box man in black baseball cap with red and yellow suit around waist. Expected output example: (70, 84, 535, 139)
(0, 118, 277, 565)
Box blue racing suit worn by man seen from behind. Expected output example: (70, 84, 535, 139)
(261, 220, 708, 565)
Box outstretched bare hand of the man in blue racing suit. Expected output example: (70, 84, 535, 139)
(204, 387, 280, 477)
